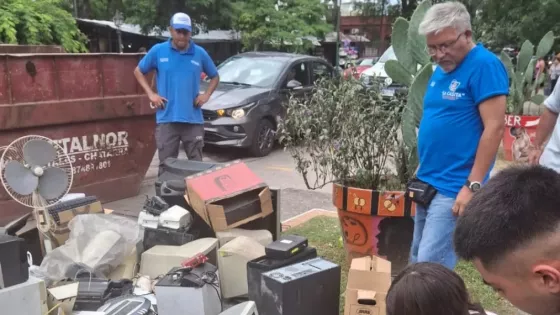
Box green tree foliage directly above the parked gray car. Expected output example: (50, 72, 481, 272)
(233, 0, 332, 50)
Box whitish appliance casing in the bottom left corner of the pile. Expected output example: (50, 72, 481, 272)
(0, 276, 48, 315)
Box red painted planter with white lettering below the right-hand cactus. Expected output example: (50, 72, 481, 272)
(502, 115, 540, 162)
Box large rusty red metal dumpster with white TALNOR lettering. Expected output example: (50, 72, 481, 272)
(0, 54, 156, 224)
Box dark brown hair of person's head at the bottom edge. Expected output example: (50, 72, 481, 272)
(386, 263, 486, 315)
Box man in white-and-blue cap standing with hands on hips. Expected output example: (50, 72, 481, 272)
(134, 13, 220, 174)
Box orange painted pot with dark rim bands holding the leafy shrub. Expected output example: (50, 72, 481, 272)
(333, 184, 416, 274)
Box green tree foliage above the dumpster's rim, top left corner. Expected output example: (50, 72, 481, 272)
(0, 0, 87, 52)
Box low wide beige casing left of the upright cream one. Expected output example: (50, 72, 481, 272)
(140, 237, 218, 279)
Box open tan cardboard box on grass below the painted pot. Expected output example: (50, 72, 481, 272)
(344, 256, 391, 315)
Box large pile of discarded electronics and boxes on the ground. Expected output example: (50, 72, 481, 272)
(0, 159, 350, 315)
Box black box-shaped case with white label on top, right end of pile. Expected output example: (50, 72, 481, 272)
(255, 258, 340, 315)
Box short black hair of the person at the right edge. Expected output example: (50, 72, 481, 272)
(454, 166, 560, 267)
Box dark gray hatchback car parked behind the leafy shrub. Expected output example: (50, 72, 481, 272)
(201, 52, 334, 156)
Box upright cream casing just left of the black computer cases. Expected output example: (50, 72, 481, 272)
(218, 236, 265, 299)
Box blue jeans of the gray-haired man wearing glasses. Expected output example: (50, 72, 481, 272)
(410, 193, 457, 270)
